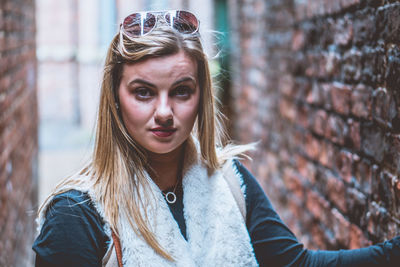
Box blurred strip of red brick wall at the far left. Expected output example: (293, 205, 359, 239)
(0, 0, 38, 266)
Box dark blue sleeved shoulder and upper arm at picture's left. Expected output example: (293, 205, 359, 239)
(33, 190, 108, 266)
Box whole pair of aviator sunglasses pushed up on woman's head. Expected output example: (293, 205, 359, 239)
(121, 10, 200, 37)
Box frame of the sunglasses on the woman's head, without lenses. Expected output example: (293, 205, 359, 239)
(120, 10, 200, 37)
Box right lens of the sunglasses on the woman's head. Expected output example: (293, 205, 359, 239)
(165, 11, 199, 33)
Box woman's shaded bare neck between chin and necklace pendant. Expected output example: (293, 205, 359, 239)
(147, 145, 184, 190)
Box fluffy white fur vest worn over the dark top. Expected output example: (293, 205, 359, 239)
(113, 158, 258, 267)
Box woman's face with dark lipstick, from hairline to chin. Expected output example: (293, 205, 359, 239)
(118, 52, 200, 154)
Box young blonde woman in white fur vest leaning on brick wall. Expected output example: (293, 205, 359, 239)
(33, 11, 400, 267)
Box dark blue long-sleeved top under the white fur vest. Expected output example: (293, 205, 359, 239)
(33, 162, 400, 267)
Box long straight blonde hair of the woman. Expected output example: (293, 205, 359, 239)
(41, 25, 253, 260)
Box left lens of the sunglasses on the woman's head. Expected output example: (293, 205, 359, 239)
(122, 13, 156, 36)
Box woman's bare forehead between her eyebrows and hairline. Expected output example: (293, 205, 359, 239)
(122, 51, 197, 80)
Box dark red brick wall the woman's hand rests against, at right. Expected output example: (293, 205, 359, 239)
(230, 0, 400, 249)
